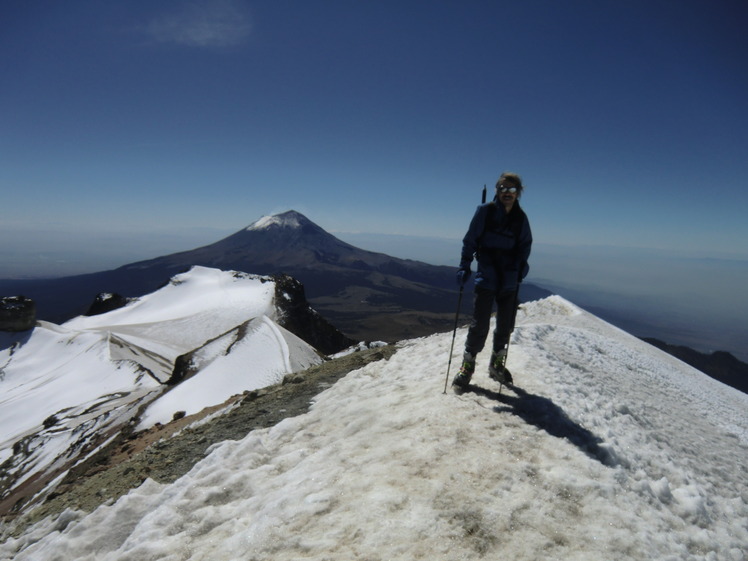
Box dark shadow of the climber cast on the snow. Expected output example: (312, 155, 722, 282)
(468, 384, 620, 467)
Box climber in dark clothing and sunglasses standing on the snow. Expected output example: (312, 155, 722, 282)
(452, 172, 532, 389)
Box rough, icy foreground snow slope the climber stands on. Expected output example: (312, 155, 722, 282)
(0, 297, 748, 561)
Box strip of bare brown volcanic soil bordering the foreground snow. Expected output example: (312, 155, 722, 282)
(5, 345, 396, 535)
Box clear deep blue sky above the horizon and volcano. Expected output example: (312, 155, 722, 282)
(0, 0, 748, 354)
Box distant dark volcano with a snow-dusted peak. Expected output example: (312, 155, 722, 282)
(0, 211, 549, 341)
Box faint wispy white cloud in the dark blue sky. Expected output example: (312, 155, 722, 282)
(145, 0, 252, 47)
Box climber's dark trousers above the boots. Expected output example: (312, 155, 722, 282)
(465, 288, 517, 356)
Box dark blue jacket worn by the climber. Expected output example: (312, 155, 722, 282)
(460, 201, 532, 292)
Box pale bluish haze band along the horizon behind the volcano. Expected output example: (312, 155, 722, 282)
(0, 227, 748, 361)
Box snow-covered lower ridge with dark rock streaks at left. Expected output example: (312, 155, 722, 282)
(0, 267, 322, 513)
